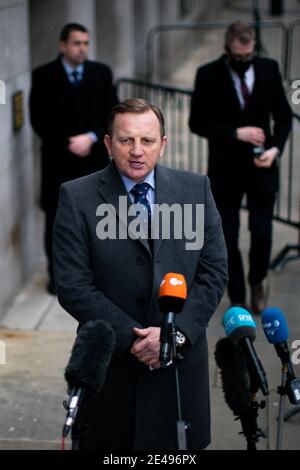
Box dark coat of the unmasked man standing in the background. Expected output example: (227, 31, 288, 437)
(30, 58, 117, 210)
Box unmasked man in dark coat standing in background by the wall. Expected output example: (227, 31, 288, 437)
(30, 23, 117, 293)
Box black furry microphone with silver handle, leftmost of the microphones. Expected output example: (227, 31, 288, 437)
(62, 320, 116, 438)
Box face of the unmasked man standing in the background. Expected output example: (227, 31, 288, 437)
(59, 31, 90, 67)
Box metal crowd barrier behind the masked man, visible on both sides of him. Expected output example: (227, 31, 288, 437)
(117, 78, 300, 239)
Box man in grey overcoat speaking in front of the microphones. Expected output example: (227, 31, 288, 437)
(54, 99, 227, 450)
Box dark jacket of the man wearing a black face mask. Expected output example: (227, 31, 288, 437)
(189, 56, 292, 193)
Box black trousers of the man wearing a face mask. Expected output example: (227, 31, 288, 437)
(212, 185, 276, 304)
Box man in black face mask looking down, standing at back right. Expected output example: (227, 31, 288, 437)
(189, 22, 291, 313)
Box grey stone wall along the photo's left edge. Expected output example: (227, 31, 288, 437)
(0, 0, 36, 314)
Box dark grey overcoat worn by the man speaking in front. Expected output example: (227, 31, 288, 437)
(54, 164, 227, 449)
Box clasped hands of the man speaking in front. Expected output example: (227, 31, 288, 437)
(130, 326, 160, 369)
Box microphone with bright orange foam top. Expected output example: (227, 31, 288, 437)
(158, 273, 187, 368)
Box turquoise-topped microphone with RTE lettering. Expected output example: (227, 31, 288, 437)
(223, 307, 269, 395)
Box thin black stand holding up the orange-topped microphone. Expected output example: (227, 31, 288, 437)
(169, 322, 189, 450)
